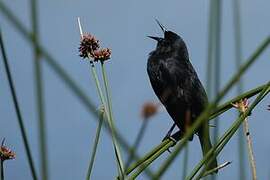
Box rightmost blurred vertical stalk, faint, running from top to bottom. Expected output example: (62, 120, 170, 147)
(232, 0, 246, 179)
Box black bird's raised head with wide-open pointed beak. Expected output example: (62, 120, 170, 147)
(148, 19, 186, 53)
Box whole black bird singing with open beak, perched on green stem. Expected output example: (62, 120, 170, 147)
(147, 21, 217, 170)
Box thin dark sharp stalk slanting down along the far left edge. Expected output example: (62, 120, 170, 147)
(0, 28, 37, 180)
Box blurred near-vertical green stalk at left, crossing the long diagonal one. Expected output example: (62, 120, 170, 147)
(30, 0, 48, 180)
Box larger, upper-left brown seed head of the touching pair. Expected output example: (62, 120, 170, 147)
(79, 33, 99, 58)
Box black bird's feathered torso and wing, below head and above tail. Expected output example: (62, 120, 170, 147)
(148, 58, 207, 130)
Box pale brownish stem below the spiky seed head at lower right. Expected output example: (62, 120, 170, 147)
(243, 118, 257, 180)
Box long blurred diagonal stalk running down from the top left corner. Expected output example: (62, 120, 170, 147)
(0, 1, 156, 177)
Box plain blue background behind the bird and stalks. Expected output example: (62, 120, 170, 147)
(0, 0, 270, 180)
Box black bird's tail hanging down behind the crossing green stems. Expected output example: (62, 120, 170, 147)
(198, 123, 218, 173)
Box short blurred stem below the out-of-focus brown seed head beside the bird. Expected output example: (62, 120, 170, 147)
(125, 119, 149, 167)
